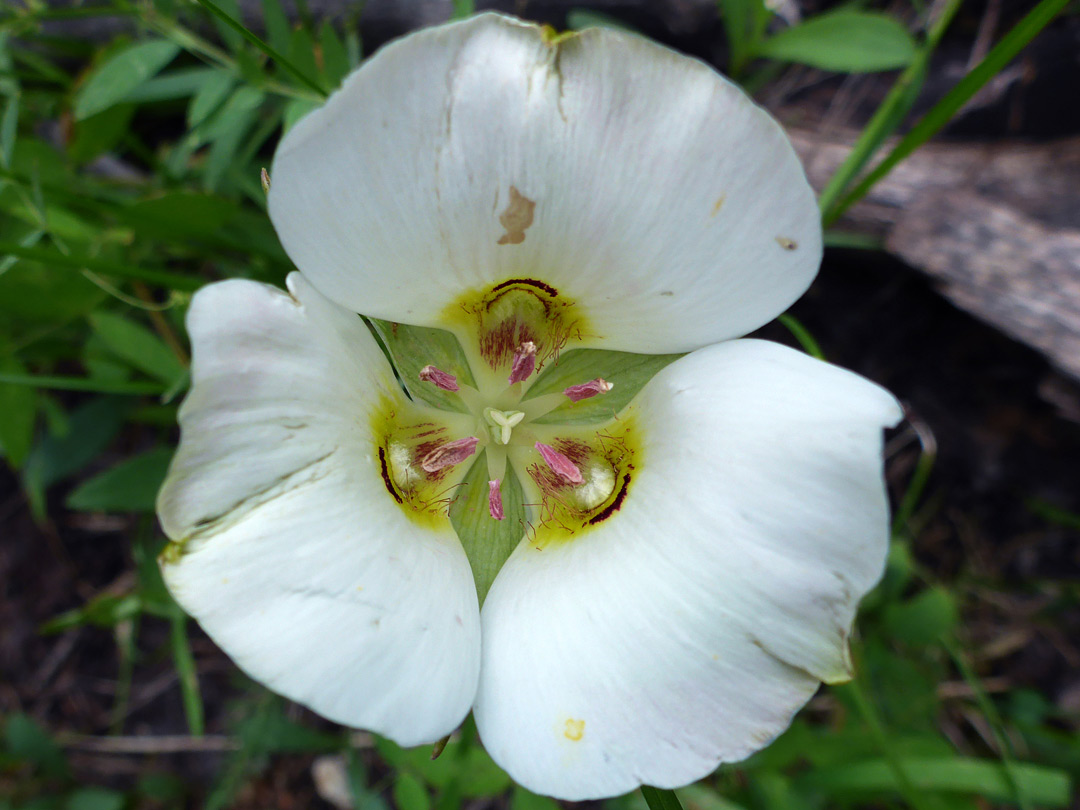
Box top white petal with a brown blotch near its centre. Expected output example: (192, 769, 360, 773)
(269, 14, 821, 352)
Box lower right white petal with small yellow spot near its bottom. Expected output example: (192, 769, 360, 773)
(474, 340, 900, 799)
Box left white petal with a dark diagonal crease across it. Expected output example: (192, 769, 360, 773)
(158, 274, 480, 745)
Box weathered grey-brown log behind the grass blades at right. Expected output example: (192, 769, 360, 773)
(792, 131, 1080, 379)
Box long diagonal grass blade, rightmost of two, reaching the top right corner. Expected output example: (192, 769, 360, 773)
(828, 0, 1069, 221)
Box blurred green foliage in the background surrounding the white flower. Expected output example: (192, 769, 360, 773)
(0, 0, 1080, 810)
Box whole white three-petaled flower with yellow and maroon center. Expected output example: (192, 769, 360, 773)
(159, 15, 900, 799)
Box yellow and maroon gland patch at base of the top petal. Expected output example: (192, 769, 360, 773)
(447, 279, 584, 375)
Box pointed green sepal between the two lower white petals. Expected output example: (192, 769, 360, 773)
(450, 450, 525, 606)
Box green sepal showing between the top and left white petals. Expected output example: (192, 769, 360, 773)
(367, 318, 476, 414)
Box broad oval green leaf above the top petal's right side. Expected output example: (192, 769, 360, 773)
(757, 9, 916, 73)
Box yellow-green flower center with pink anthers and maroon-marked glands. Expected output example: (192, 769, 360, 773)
(371, 279, 639, 557)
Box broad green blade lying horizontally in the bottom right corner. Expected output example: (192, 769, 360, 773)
(798, 757, 1071, 807)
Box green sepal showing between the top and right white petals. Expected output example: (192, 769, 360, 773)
(525, 349, 683, 424)
